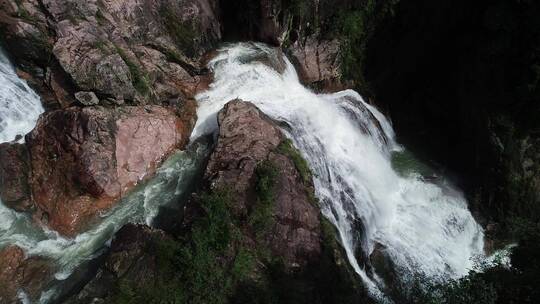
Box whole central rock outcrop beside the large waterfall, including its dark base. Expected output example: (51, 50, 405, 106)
(205, 100, 365, 303)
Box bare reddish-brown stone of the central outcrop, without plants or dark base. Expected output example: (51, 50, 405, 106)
(202, 100, 321, 267)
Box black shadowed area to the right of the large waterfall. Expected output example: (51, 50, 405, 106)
(366, 0, 540, 221)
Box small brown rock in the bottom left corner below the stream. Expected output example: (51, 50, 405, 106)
(0, 246, 52, 303)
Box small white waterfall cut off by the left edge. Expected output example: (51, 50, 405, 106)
(0, 48, 43, 143)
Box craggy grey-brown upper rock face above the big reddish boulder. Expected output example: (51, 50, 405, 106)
(0, 0, 221, 107)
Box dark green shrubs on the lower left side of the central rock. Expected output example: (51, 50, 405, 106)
(109, 190, 255, 304)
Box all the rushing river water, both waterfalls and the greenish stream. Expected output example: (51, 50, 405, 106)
(0, 43, 483, 303)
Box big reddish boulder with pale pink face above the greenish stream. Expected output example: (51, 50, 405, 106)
(0, 106, 194, 235)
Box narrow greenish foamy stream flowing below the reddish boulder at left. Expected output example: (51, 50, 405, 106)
(0, 143, 209, 280)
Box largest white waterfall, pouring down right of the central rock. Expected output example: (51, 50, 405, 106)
(192, 43, 483, 296)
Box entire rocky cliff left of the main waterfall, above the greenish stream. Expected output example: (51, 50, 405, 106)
(0, 0, 213, 236)
